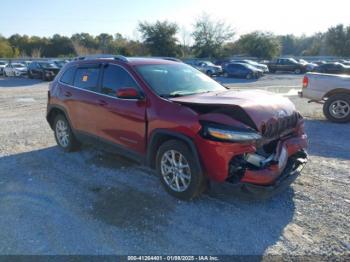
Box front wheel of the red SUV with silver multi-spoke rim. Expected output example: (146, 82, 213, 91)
(156, 140, 207, 200)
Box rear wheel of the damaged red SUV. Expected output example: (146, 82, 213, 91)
(53, 114, 79, 152)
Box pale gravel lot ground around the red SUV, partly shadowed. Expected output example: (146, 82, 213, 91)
(0, 75, 350, 255)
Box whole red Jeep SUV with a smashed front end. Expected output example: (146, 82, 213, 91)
(47, 56, 307, 199)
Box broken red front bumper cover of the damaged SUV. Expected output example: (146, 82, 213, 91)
(196, 131, 307, 184)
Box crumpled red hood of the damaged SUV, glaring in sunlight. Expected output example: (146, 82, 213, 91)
(170, 90, 295, 131)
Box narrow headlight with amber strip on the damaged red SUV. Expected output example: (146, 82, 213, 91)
(203, 125, 262, 142)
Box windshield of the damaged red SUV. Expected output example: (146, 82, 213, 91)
(136, 64, 226, 97)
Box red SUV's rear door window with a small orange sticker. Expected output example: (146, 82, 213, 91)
(74, 67, 100, 91)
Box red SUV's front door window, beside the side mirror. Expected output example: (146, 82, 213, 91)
(101, 65, 138, 96)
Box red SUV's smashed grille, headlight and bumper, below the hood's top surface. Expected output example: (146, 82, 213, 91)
(194, 105, 307, 195)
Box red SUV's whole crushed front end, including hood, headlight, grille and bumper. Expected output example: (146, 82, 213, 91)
(170, 92, 307, 194)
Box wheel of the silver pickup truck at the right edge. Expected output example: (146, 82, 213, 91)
(323, 94, 350, 123)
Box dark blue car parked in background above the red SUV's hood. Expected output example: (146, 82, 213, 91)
(223, 63, 264, 79)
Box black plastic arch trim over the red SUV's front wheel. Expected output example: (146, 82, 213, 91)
(146, 129, 203, 172)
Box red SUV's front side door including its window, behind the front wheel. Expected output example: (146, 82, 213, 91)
(97, 64, 146, 154)
